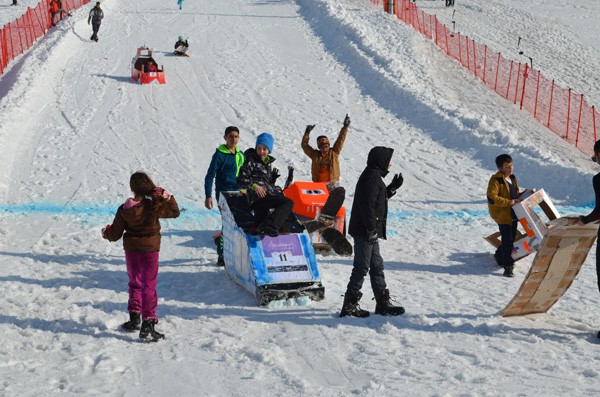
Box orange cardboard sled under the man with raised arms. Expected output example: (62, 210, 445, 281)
(283, 182, 346, 251)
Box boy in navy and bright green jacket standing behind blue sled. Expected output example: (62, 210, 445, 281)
(204, 125, 244, 266)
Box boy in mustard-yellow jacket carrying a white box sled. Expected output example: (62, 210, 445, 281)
(487, 154, 522, 277)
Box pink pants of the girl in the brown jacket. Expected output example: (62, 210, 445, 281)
(125, 251, 158, 320)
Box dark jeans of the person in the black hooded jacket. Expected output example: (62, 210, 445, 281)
(346, 236, 387, 296)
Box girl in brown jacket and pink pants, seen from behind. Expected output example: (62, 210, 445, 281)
(102, 172, 179, 341)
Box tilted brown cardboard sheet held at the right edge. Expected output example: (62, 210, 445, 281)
(500, 218, 598, 317)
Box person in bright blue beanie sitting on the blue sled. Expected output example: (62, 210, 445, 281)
(237, 132, 294, 237)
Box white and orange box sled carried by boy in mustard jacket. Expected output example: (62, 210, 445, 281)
(484, 189, 560, 261)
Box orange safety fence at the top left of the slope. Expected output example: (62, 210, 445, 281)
(0, 0, 90, 75)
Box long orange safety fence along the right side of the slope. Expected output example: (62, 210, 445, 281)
(370, 0, 600, 154)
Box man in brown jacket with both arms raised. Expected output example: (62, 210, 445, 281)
(301, 115, 350, 233)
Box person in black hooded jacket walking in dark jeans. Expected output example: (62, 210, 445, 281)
(340, 146, 404, 317)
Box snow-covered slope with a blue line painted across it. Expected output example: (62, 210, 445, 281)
(0, 0, 600, 396)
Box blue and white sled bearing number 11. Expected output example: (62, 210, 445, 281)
(219, 192, 325, 306)
